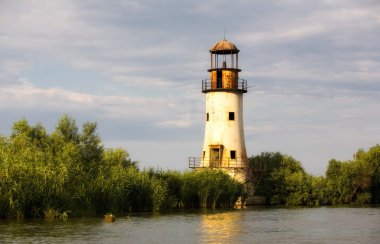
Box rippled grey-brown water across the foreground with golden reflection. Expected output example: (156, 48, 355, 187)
(0, 207, 380, 243)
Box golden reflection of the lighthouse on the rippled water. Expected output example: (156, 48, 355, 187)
(201, 211, 244, 243)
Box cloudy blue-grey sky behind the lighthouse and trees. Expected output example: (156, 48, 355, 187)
(0, 0, 380, 175)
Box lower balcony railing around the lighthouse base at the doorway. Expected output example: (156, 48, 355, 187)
(189, 157, 248, 169)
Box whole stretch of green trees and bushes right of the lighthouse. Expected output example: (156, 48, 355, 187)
(249, 145, 380, 206)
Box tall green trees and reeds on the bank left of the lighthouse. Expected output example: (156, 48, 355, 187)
(0, 115, 242, 218)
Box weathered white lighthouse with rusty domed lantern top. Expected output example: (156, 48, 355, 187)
(189, 39, 248, 183)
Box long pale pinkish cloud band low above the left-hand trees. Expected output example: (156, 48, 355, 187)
(0, 81, 202, 128)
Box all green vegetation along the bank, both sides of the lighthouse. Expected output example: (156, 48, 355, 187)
(0, 115, 380, 218)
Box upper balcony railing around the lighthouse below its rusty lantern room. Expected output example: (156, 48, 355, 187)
(202, 79, 248, 93)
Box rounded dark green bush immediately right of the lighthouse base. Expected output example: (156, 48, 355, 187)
(249, 152, 324, 206)
